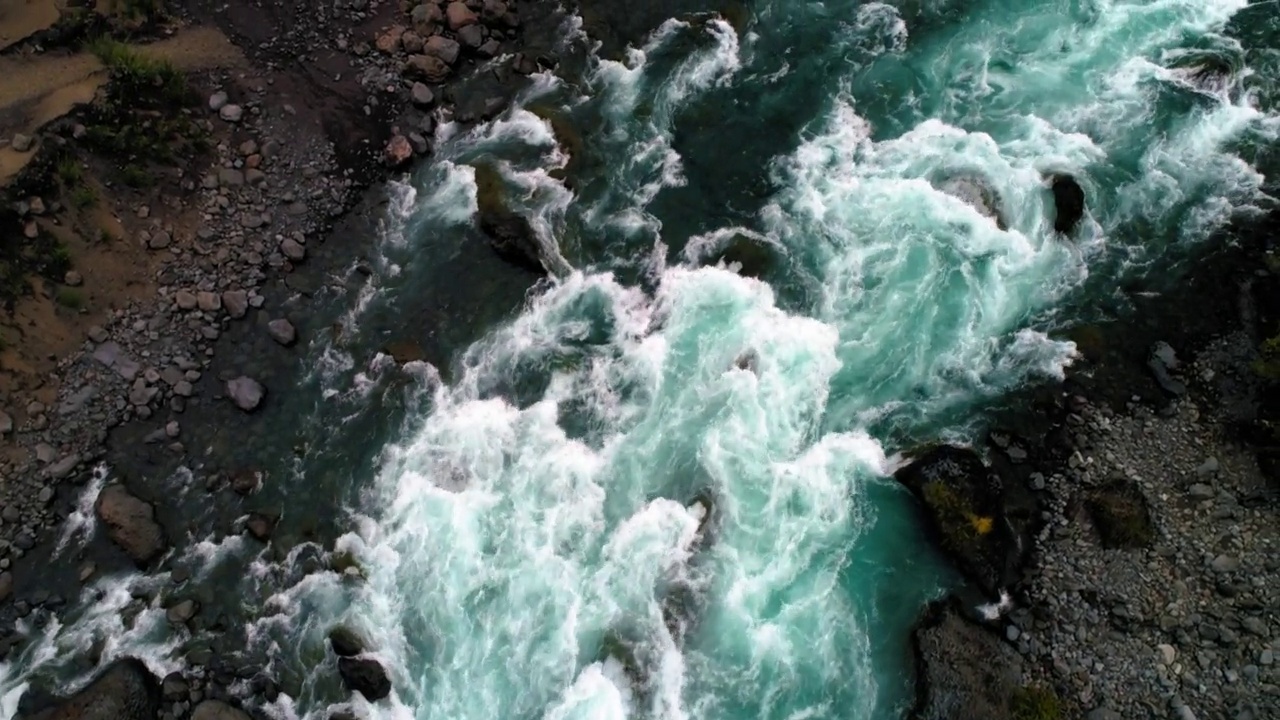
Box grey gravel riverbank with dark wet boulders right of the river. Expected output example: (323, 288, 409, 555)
(900, 215, 1280, 720)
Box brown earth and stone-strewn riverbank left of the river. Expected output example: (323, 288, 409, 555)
(0, 0, 561, 719)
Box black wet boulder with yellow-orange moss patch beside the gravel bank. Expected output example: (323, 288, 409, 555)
(895, 446, 1025, 598)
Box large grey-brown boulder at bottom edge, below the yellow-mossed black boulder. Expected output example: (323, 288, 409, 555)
(911, 603, 1023, 720)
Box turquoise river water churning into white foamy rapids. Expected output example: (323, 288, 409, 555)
(6, 0, 1276, 720)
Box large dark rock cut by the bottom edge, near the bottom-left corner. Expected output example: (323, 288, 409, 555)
(20, 657, 160, 720)
